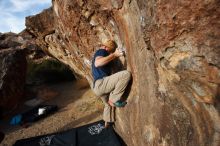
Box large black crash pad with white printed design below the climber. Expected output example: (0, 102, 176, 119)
(13, 121, 121, 146)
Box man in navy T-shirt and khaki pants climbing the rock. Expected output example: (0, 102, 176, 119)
(92, 40, 131, 127)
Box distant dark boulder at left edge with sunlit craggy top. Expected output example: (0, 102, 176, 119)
(0, 31, 45, 114)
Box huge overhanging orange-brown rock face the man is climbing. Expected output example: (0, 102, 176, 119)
(26, 0, 220, 146)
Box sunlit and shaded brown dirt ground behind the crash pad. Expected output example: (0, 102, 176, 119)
(0, 80, 103, 146)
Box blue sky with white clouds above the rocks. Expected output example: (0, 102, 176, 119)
(0, 0, 52, 33)
